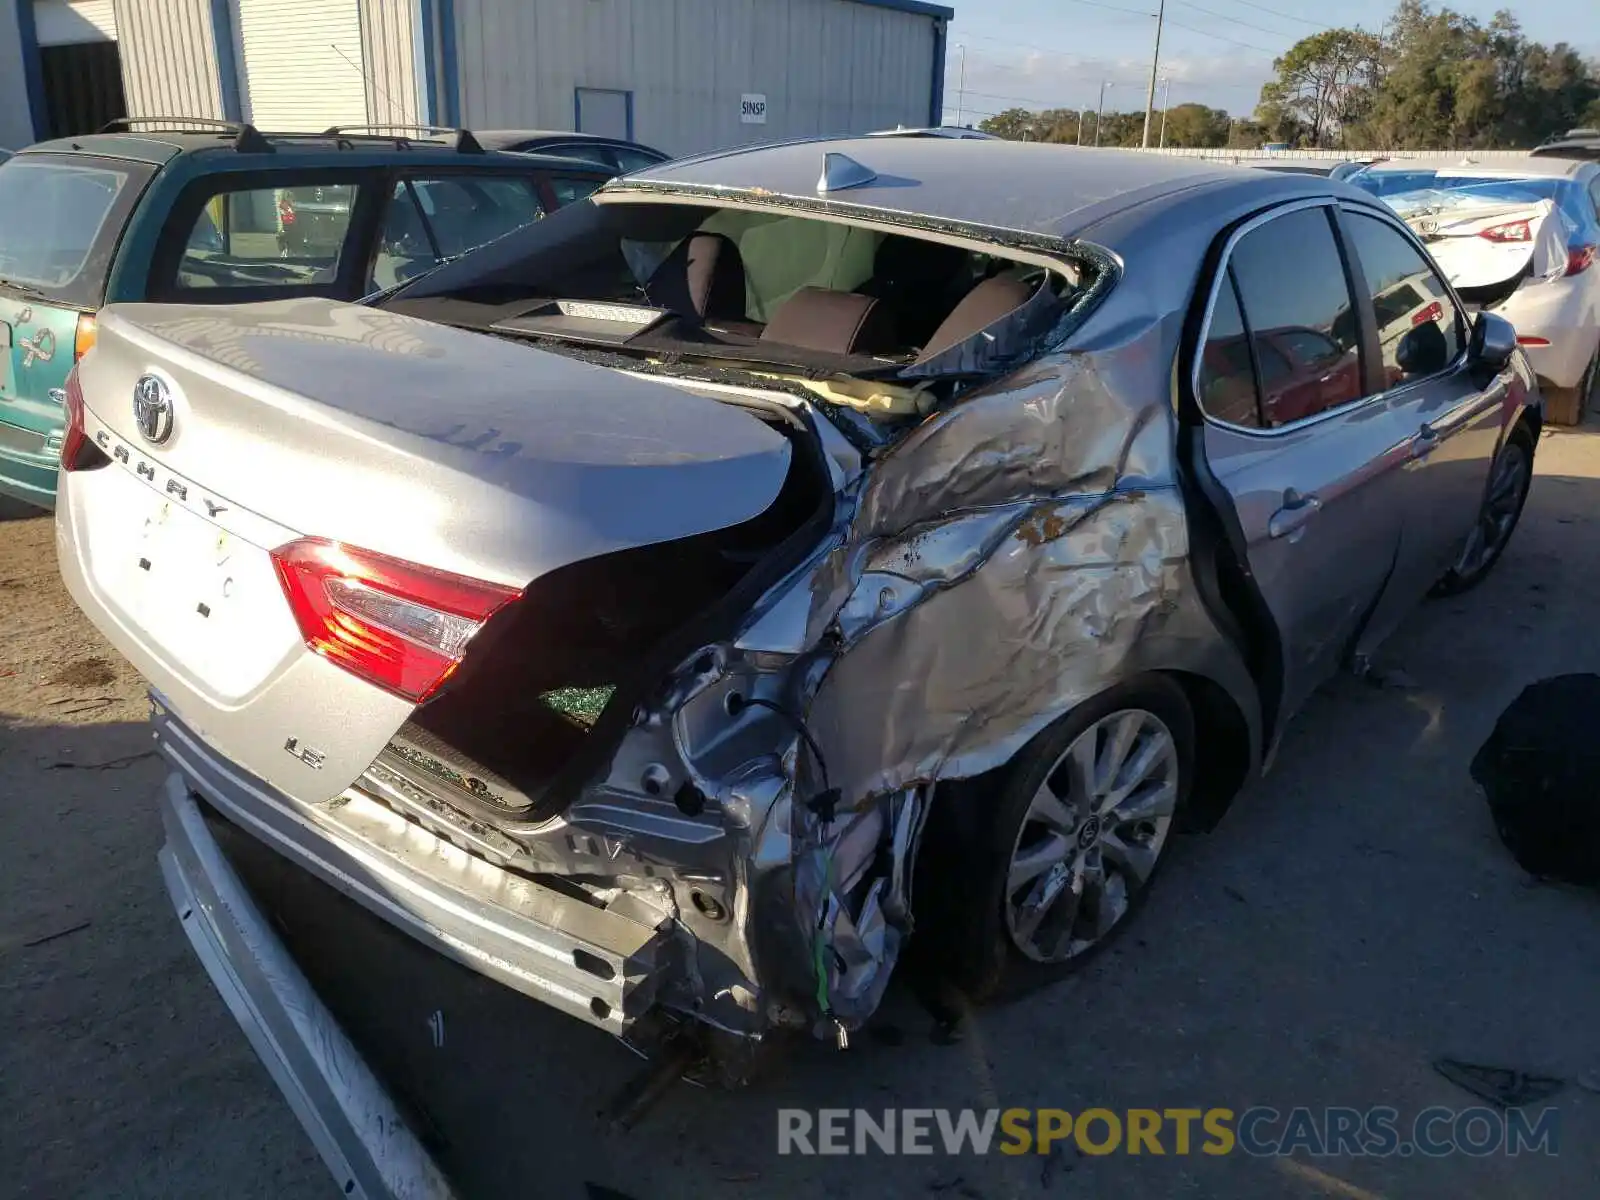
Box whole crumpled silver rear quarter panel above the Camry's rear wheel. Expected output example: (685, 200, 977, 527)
(808, 342, 1195, 803)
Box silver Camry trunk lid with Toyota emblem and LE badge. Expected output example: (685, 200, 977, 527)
(56, 301, 790, 803)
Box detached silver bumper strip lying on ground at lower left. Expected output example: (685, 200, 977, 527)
(160, 774, 454, 1200)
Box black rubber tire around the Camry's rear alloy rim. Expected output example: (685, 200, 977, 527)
(912, 675, 1195, 1003)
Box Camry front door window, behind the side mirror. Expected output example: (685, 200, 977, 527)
(1344, 211, 1466, 387)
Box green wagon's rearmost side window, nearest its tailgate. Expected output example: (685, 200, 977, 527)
(176, 182, 360, 293)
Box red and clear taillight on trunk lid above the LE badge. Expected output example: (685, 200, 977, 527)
(272, 538, 522, 702)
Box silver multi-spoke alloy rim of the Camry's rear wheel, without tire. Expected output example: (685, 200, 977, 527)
(1005, 709, 1179, 963)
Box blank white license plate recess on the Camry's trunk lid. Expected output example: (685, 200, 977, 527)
(83, 464, 301, 702)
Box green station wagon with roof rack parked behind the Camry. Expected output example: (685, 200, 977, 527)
(0, 117, 611, 507)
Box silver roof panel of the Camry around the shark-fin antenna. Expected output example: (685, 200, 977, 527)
(595, 138, 1292, 238)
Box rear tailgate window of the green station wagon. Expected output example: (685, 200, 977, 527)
(0, 154, 152, 307)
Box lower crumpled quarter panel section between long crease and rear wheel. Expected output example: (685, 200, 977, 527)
(811, 490, 1189, 809)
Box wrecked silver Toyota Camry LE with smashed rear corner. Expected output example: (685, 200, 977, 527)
(56, 138, 1541, 1177)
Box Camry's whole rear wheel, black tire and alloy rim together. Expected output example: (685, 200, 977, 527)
(918, 677, 1194, 1000)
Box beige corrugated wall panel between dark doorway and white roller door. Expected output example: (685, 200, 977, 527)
(117, 0, 224, 120)
